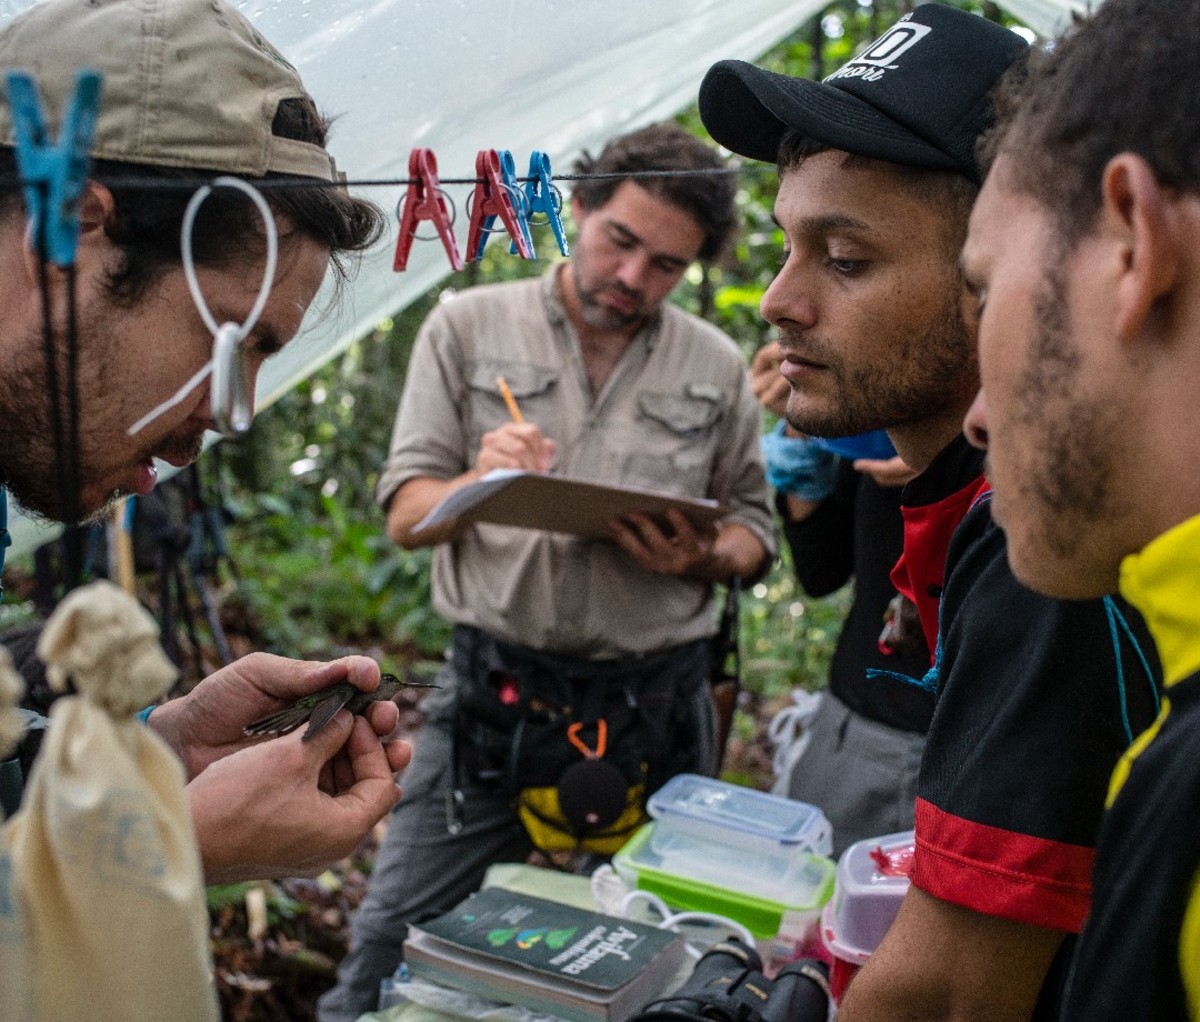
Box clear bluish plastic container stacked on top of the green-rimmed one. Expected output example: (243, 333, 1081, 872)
(647, 774, 833, 858)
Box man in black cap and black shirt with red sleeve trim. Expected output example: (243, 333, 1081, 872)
(700, 4, 1157, 1022)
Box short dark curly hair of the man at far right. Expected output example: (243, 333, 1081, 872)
(979, 0, 1200, 250)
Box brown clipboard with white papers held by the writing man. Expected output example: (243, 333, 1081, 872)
(413, 469, 728, 539)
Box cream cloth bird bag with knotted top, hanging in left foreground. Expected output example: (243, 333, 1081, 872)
(5, 582, 220, 1022)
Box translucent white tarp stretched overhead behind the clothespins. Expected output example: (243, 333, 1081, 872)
(0, 0, 1081, 553)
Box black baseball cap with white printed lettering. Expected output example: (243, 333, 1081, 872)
(700, 4, 1028, 182)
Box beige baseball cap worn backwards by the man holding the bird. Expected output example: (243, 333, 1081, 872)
(0, 0, 338, 181)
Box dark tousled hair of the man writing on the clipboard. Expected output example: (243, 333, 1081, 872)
(574, 121, 738, 260)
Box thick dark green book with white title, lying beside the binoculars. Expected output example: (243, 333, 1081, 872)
(404, 888, 688, 1022)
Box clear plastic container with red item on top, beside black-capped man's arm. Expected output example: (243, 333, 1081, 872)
(822, 830, 914, 954)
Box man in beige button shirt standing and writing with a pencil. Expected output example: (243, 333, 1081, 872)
(322, 125, 774, 1022)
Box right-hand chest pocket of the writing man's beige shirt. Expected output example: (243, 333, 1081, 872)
(624, 384, 725, 497)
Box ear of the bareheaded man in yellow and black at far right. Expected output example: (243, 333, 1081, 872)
(1100, 152, 1181, 341)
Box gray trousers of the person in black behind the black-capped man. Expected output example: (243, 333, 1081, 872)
(787, 692, 925, 858)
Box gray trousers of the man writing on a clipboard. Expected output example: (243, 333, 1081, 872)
(317, 647, 715, 1022)
